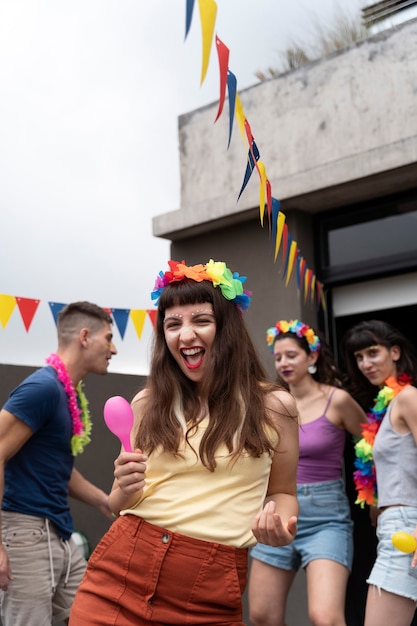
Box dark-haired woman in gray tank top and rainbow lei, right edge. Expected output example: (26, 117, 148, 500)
(343, 320, 417, 626)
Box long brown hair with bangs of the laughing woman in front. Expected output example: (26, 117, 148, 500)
(136, 278, 293, 471)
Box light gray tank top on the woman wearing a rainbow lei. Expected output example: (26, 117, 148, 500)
(372, 399, 417, 507)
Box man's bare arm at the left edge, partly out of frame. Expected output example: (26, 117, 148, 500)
(0, 409, 33, 591)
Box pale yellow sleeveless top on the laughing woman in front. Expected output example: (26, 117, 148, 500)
(121, 418, 272, 548)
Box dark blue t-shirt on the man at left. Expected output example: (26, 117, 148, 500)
(2, 366, 74, 539)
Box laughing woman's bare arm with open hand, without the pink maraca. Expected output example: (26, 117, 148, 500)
(252, 391, 298, 546)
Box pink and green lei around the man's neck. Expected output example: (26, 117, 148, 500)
(46, 353, 92, 456)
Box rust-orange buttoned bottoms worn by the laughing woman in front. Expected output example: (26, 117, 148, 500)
(69, 515, 248, 626)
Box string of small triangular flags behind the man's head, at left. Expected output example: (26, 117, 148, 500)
(0, 294, 156, 339)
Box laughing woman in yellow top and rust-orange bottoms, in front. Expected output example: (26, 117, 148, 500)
(70, 260, 298, 626)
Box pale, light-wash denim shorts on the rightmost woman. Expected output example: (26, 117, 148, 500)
(366, 506, 417, 601)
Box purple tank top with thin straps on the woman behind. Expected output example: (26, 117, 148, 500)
(297, 389, 346, 485)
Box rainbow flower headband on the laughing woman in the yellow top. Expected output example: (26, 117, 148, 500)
(151, 259, 252, 310)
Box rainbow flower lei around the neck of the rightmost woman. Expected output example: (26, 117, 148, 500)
(353, 374, 411, 508)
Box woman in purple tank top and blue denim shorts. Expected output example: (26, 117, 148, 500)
(249, 320, 366, 626)
